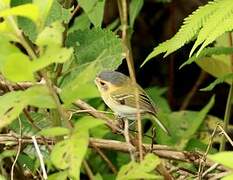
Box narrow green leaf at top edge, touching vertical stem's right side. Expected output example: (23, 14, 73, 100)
(129, 0, 144, 27)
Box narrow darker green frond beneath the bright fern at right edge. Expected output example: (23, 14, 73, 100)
(179, 47, 233, 69)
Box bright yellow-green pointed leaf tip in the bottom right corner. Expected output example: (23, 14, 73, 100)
(207, 151, 233, 169)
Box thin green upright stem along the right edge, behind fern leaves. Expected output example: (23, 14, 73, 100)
(219, 32, 233, 151)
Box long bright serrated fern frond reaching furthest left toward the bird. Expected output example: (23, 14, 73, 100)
(141, 0, 222, 66)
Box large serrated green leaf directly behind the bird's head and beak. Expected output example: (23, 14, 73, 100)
(61, 29, 123, 103)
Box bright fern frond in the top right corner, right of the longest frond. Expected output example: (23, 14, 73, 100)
(190, 0, 233, 56)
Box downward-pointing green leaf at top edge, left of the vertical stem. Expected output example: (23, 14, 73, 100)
(78, 0, 105, 27)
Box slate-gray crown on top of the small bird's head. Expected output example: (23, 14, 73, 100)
(97, 71, 128, 86)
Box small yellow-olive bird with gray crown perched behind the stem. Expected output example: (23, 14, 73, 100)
(95, 71, 169, 134)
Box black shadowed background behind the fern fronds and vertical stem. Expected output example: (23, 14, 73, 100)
(101, 0, 229, 121)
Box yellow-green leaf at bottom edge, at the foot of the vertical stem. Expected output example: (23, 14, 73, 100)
(116, 154, 163, 180)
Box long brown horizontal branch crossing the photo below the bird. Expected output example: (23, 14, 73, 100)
(0, 134, 229, 171)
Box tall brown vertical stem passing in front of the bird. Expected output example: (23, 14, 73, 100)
(117, 0, 143, 162)
